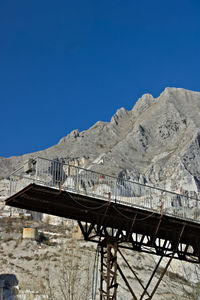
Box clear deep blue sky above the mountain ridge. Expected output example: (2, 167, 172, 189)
(0, 0, 200, 157)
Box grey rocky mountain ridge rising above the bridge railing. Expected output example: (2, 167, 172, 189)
(0, 88, 200, 197)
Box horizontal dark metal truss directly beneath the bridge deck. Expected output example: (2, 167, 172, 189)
(78, 221, 200, 263)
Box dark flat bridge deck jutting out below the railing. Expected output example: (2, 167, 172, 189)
(6, 183, 200, 262)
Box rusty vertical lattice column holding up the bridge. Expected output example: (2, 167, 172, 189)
(100, 242, 118, 300)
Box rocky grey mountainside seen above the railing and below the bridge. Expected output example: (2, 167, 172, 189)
(0, 88, 200, 300)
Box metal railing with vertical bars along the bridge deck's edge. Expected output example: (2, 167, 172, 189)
(10, 157, 200, 222)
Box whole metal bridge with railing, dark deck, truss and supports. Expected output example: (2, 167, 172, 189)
(6, 158, 200, 300)
